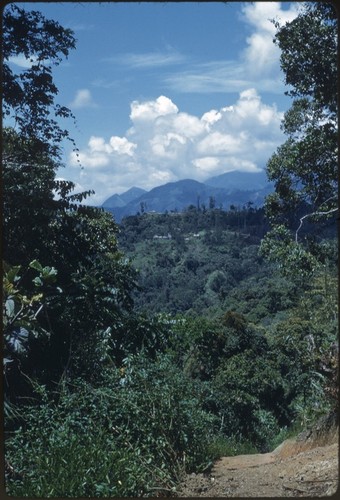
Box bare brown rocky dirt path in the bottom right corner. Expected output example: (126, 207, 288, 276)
(178, 426, 340, 498)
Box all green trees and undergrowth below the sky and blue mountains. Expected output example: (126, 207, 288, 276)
(2, 3, 338, 497)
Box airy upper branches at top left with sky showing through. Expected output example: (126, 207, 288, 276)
(2, 4, 76, 157)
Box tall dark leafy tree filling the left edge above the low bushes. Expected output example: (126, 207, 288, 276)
(3, 5, 138, 392)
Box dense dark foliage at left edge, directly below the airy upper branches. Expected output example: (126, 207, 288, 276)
(3, 128, 95, 265)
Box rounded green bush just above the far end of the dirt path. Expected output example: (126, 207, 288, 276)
(211, 350, 285, 452)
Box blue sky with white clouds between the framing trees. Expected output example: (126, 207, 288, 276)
(6, 2, 299, 205)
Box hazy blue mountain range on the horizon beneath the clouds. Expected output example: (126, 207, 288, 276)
(102, 170, 273, 222)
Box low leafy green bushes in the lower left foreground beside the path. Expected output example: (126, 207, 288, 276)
(6, 354, 213, 497)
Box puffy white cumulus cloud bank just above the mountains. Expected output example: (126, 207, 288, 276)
(70, 88, 283, 203)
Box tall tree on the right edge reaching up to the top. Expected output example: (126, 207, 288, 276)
(262, 2, 337, 269)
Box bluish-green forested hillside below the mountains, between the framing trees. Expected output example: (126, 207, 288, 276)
(118, 204, 336, 321)
